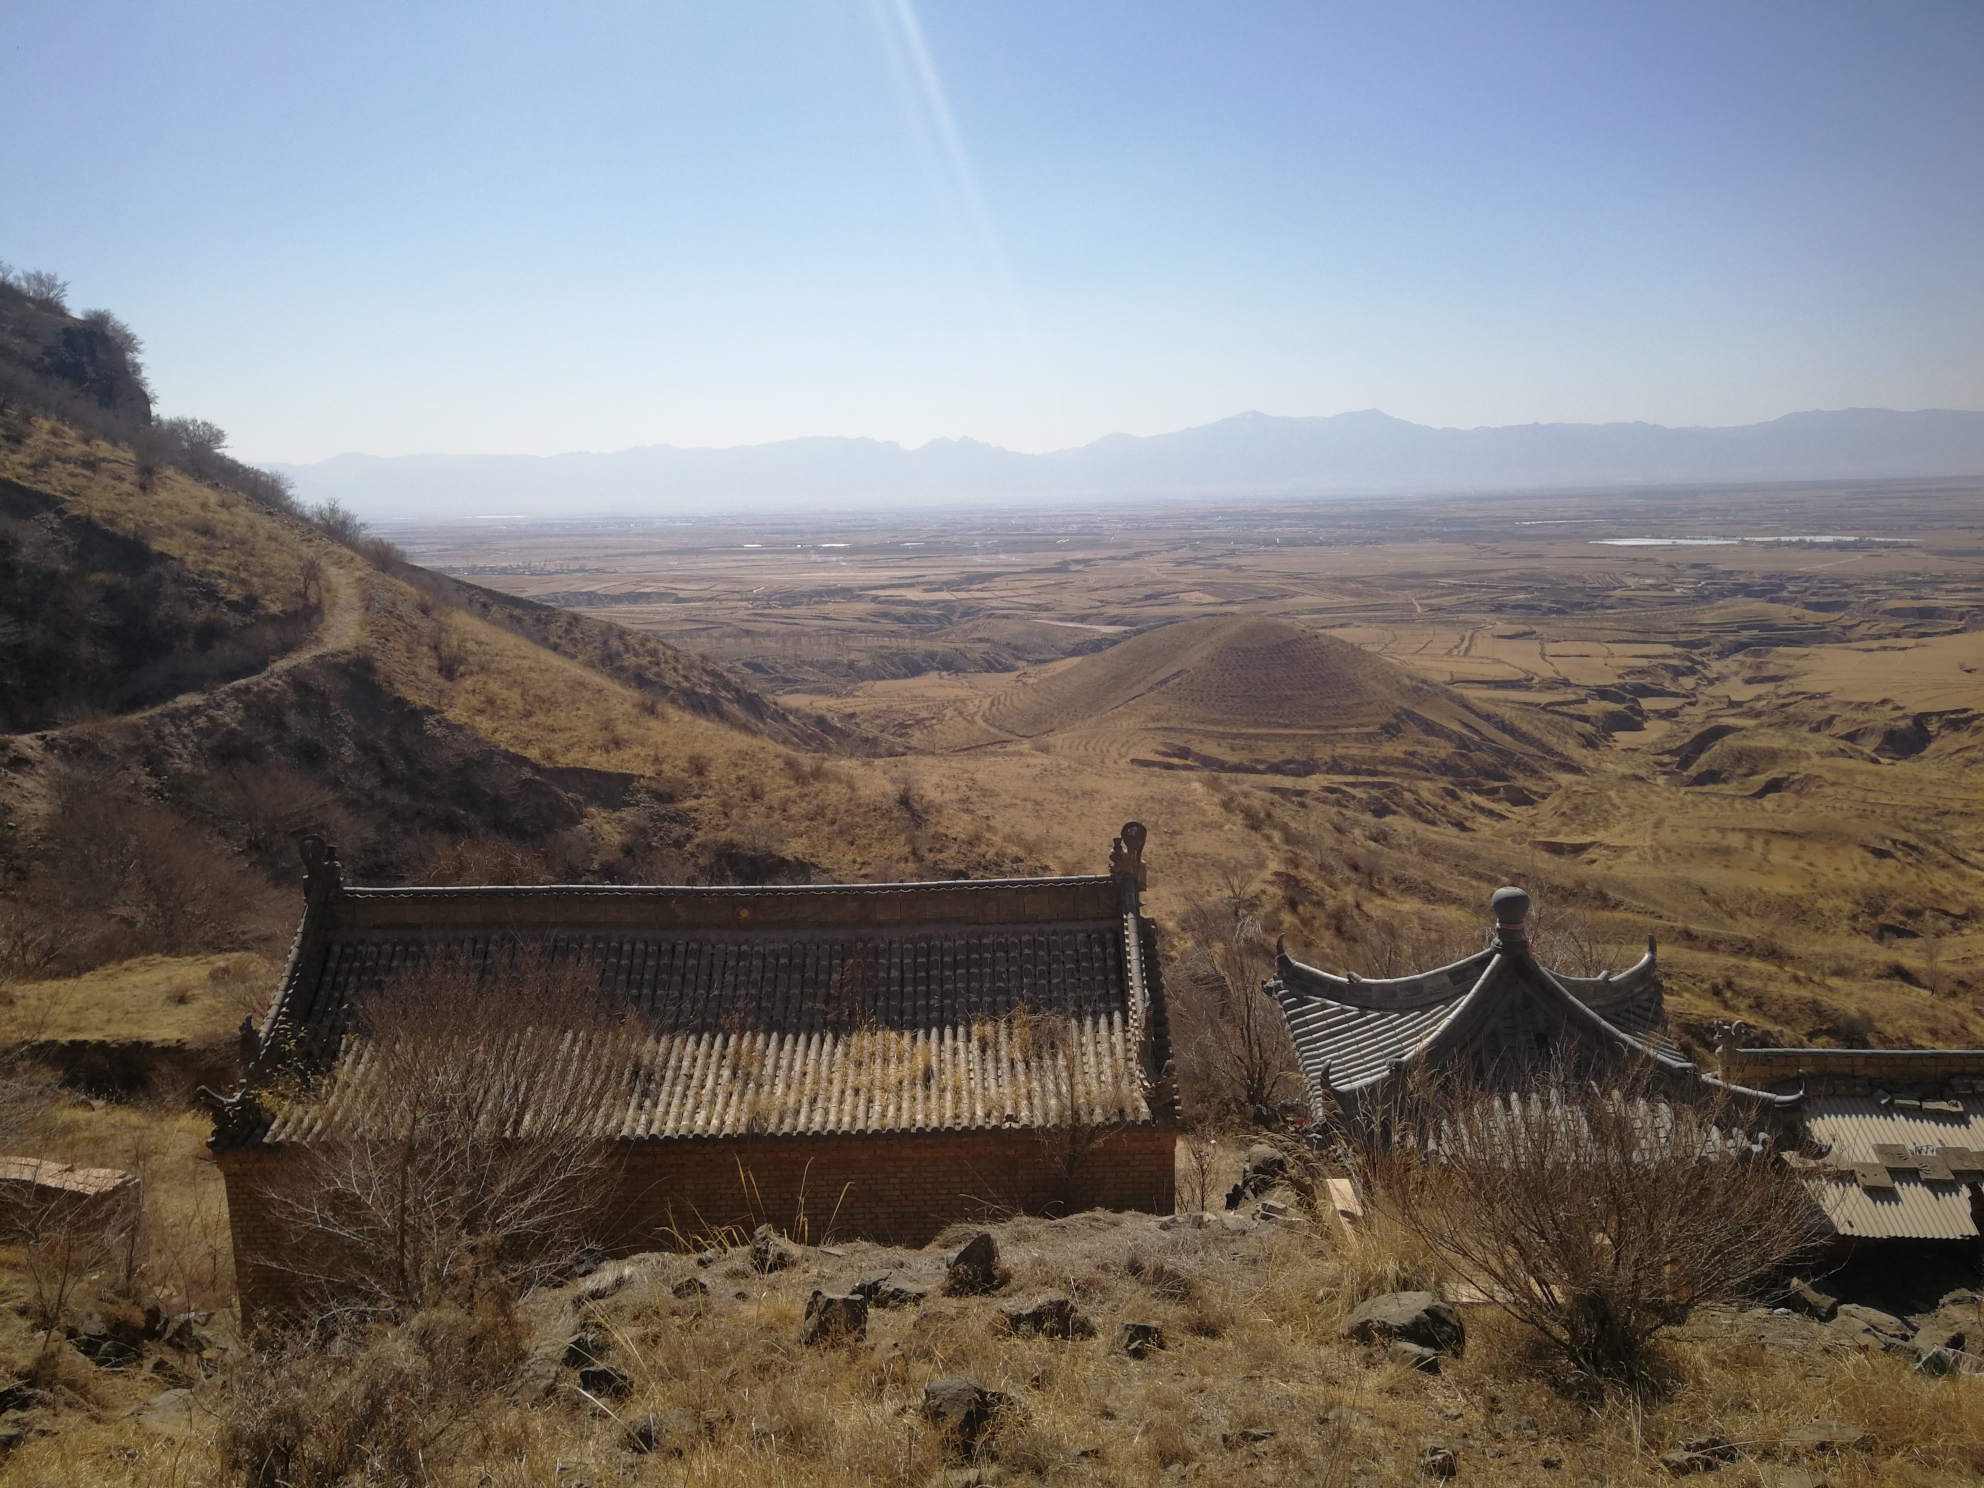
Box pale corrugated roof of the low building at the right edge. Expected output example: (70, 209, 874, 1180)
(1805, 1095, 1984, 1240)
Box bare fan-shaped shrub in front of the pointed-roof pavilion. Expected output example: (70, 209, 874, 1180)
(1367, 1067, 1821, 1391)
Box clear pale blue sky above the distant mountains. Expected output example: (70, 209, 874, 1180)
(0, 0, 1984, 460)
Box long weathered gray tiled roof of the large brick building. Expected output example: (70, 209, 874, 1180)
(234, 845, 1173, 1143)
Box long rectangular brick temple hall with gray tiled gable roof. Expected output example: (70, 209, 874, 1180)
(212, 821, 1177, 1300)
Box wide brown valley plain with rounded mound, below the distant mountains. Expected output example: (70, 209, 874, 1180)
(385, 480, 1984, 1050)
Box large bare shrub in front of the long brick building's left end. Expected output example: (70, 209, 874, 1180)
(256, 946, 635, 1327)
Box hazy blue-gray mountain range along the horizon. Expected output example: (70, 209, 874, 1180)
(268, 409, 1984, 520)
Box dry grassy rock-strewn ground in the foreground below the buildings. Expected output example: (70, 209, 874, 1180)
(0, 1212, 1984, 1488)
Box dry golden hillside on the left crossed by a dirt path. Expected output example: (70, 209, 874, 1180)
(0, 421, 1024, 877)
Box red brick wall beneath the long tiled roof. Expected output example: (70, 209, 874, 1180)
(220, 1129, 1177, 1311)
